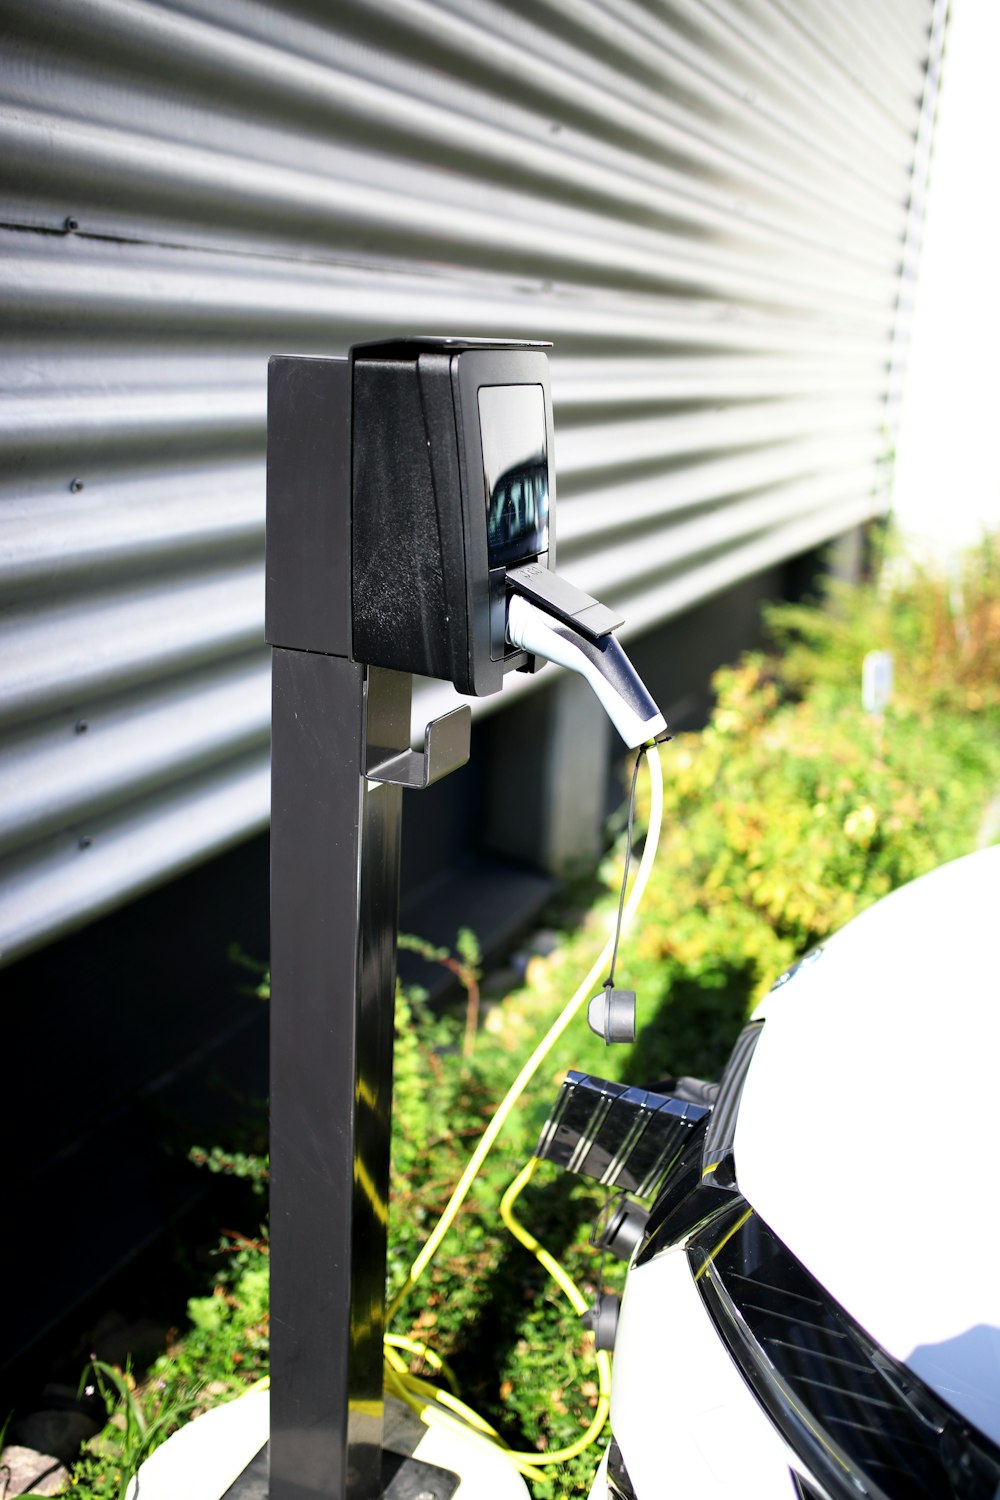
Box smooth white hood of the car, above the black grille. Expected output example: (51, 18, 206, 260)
(735, 848, 1000, 1443)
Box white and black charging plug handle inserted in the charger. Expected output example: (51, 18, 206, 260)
(507, 594, 667, 750)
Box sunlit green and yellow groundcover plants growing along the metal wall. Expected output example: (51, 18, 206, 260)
(72, 540, 1000, 1500)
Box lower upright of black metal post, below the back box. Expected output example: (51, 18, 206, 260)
(270, 650, 402, 1500)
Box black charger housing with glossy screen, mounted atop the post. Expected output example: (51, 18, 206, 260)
(351, 339, 555, 696)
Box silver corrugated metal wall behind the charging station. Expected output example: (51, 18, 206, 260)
(0, 0, 943, 960)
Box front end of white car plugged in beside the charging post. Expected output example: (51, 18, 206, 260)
(571, 848, 1000, 1500)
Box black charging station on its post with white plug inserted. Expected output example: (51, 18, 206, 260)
(265, 339, 666, 1500)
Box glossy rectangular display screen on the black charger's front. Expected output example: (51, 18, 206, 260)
(480, 386, 549, 569)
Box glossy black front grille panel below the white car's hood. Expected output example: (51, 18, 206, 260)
(688, 1199, 1000, 1500)
